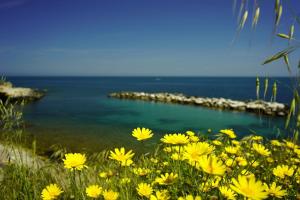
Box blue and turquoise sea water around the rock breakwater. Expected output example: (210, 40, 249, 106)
(9, 77, 290, 151)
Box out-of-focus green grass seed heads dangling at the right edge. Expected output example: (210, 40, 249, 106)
(234, 0, 300, 140)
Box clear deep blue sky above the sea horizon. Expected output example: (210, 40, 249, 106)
(0, 0, 300, 76)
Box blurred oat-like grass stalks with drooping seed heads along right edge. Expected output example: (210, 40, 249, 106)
(233, 0, 300, 141)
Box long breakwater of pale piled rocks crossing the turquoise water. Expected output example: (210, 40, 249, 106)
(109, 92, 289, 116)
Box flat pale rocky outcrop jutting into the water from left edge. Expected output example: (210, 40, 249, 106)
(0, 82, 46, 101)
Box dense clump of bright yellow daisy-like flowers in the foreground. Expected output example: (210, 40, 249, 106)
(41, 128, 300, 200)
